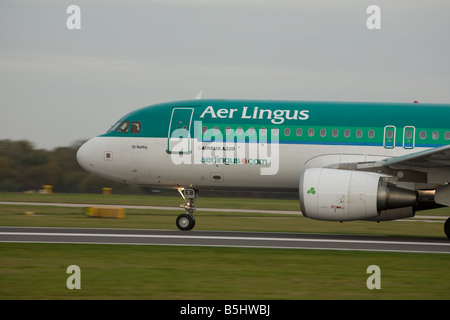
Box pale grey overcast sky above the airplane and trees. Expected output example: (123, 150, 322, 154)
(0, 0, 450, 149)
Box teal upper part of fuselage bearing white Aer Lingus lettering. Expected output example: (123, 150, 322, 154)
(98, 100, 450, 147)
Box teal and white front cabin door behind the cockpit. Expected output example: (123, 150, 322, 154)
(167, 108, 194, 153)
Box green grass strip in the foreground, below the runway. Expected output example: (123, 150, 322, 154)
(0, 243, 450, 300)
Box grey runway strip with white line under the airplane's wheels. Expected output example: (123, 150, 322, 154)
(0, 227, 450, 254)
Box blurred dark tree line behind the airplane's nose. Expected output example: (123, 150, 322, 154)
(0, 140, 151, 194)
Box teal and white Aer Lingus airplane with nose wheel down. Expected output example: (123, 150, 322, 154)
(77, 99, 450, 237)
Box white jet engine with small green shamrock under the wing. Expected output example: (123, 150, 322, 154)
(299, 168, 417, 221)
